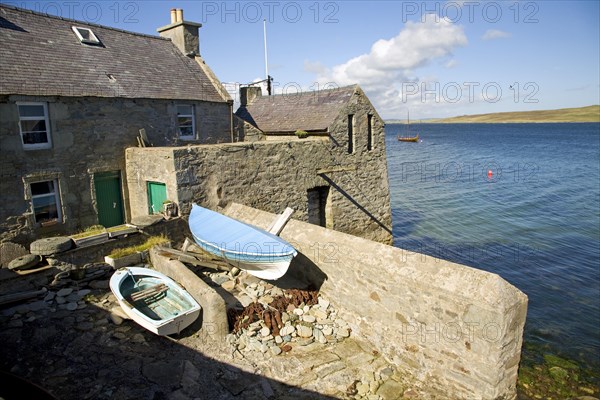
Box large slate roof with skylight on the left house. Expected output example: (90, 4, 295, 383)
(0, 5, 226, 102)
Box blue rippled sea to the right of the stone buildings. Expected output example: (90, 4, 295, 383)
(386, 123, 600, 369)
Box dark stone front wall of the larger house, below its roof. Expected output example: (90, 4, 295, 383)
(0, 96, 231, 243)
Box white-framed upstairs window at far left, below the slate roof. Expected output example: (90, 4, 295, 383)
(17, 103, 52, 150)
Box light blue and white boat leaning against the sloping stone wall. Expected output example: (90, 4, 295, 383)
(189, 204, 298, 280)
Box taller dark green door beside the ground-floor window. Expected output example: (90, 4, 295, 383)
(94, 171, 125, 228)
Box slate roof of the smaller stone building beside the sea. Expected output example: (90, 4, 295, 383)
(235, 85, 358, 133)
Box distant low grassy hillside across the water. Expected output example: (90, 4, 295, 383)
(422, 105, 600, 124)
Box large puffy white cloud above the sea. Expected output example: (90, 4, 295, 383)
(304, 14, 468, 116)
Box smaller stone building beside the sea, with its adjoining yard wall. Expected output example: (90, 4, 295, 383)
(126, 86, 392, 244)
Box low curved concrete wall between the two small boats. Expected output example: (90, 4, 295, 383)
(150, 247, 229, 340)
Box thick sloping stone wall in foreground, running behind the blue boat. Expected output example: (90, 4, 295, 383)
(224, 204, 527, 400)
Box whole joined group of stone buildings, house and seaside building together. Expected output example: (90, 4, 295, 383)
(0, 6, 391, 243)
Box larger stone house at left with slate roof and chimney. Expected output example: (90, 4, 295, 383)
(0, 5, 233, 242)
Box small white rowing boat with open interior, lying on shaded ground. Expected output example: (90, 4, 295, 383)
(110, 267, 201, 336)
